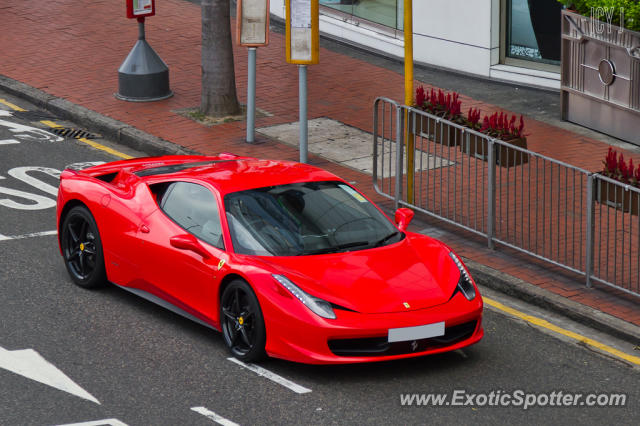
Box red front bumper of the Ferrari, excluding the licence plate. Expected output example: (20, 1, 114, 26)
(260, 286, 484, 364)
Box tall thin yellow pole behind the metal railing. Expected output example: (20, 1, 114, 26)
(404, 0, 415, 203)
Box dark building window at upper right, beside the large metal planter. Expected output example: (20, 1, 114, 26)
(504, 0, 562, 65)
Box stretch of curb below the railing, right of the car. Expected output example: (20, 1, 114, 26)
(464, 259, 640, 345)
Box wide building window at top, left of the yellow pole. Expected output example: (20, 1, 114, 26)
(320, 0, 404, 30)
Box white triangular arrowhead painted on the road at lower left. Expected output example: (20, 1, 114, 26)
(0, 346, 100, 405)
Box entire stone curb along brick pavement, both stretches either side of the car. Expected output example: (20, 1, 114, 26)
(0, 75, 640, 344)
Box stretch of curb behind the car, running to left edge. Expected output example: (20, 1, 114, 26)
(0, 75, 199, 155)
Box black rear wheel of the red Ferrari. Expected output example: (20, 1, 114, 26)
(60, 206, 107, 288)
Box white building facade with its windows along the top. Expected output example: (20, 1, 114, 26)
(270, 0, 562, 89)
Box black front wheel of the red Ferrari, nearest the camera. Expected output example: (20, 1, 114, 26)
(220, 280, 267, 362)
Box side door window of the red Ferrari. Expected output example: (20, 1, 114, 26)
(160, 182, 224, 250)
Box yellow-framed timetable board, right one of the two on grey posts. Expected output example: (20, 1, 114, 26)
(286, 0, 320, 65)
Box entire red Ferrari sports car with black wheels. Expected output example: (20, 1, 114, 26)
(57, 154, 484, 364)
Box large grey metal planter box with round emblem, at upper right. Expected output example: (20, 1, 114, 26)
(561, 10, 640, 145)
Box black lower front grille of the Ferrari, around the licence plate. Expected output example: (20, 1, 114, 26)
(329, 321, 477, 356)
